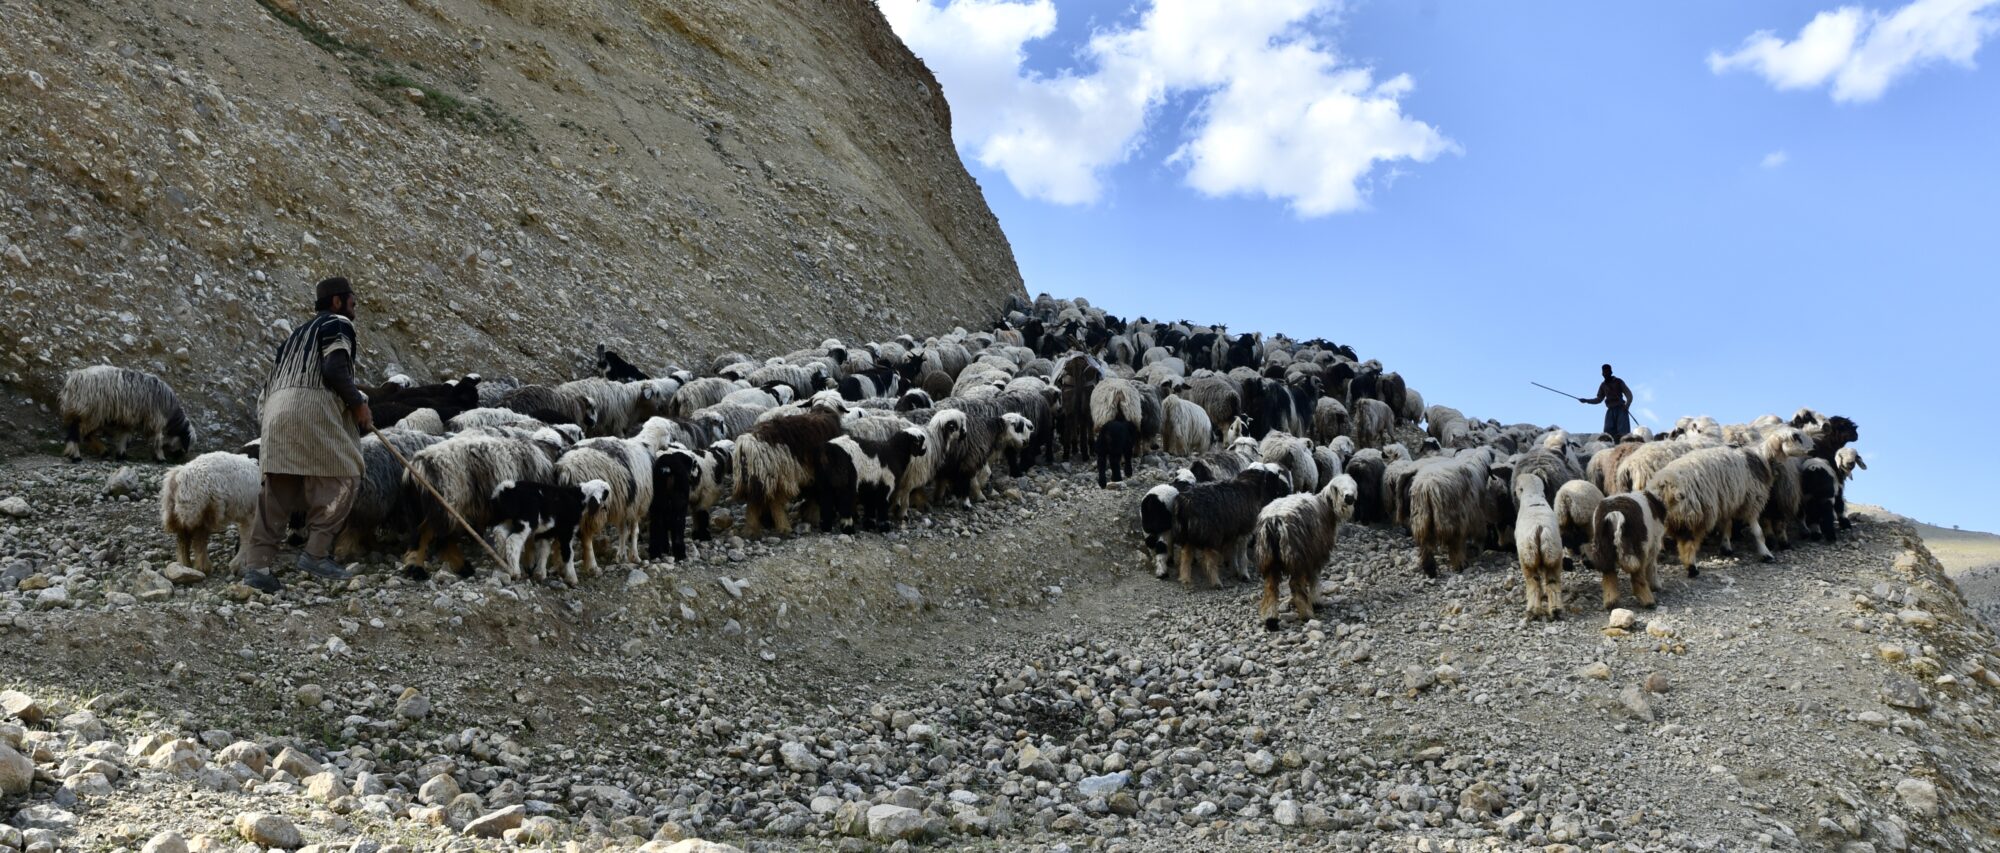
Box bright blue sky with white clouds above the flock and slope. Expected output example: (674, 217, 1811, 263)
(880, 0, 2000, 531)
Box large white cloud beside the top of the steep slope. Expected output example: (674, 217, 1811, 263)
(878, 0, 1458, 216)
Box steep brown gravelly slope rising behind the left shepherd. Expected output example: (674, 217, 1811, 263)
(0, 0, 1022, 450)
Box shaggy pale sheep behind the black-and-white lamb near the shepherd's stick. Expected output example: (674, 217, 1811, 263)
(400, 429, 566, 581)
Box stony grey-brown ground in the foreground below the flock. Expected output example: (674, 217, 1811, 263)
(0, 450, 2000, 853)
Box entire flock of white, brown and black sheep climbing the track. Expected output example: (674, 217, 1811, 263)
(60, 294, 1866, 629)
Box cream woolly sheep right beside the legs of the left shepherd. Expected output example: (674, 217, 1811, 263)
(160, 451, 264, 575)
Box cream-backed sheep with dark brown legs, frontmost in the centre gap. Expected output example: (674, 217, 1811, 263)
(1250, 475, 1358, 631)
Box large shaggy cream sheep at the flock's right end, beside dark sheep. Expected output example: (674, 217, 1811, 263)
(1628, 427, 1812, 577)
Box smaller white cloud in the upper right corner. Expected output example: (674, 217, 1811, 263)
(1708, 0, 2000, 102)
